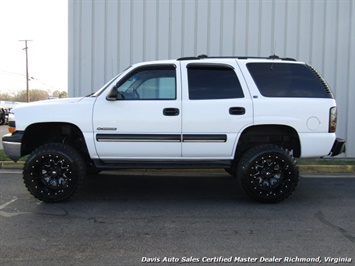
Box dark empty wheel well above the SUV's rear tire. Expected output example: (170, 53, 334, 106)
(236, 125, 301, 159)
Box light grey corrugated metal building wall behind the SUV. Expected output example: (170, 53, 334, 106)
(68, 0, 355, 157)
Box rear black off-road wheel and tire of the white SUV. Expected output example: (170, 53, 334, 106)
(237, 144, 299, 203)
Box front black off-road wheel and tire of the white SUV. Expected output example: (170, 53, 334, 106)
(23, 143, 86, 202)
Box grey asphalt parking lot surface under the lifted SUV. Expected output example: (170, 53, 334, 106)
(0, 169, 355, 265)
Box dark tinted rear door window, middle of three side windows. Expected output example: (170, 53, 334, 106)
(188, 64, 244, 100)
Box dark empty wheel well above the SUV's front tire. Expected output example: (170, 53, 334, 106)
(21, 123, 88, 156)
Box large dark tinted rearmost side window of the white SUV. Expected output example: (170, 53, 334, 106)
(247, 62, 333, 98)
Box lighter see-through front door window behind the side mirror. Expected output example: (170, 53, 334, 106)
(115, 65, 176, 100)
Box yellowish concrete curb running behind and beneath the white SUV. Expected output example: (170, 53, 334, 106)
(0, 161, 355, 173)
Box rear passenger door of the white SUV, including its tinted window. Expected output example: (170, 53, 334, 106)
(181, 60, 253, 159)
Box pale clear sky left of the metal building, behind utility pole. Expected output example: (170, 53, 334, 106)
(0, 0, 68, 94)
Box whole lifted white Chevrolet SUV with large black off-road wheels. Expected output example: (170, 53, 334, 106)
(3, 56, 345, 202)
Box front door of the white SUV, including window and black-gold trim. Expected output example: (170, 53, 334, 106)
(93, 64, 181, 160)
